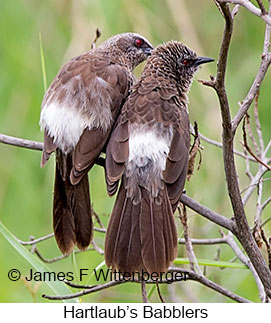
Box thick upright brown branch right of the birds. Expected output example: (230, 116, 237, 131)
(204, 1, 271, 297)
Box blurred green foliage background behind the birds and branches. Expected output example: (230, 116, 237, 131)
(0, 0, 271, 302)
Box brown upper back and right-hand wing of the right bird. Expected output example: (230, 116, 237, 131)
(134, 77, 190, 212)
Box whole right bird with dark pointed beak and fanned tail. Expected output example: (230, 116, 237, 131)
(105, 42, 212, 273)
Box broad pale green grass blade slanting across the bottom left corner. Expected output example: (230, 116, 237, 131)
(0, 221, 75, 303)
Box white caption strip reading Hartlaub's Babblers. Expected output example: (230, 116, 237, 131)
(0, 303, 271, 323)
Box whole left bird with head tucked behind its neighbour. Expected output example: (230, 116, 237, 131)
(40, 33, 155, 254)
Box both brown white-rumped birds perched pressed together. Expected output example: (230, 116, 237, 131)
(40, 33, 213, 273)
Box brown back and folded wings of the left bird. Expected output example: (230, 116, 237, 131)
(42, 53, 133, 184)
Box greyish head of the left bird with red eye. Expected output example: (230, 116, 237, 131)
(99, 33, 153, 70)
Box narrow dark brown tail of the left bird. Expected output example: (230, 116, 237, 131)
(53, 156, 93, 254)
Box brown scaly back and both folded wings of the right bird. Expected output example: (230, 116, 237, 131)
(106, 78, 190, 200)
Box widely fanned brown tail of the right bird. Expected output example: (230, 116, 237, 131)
(105, 184, 178, 273)
